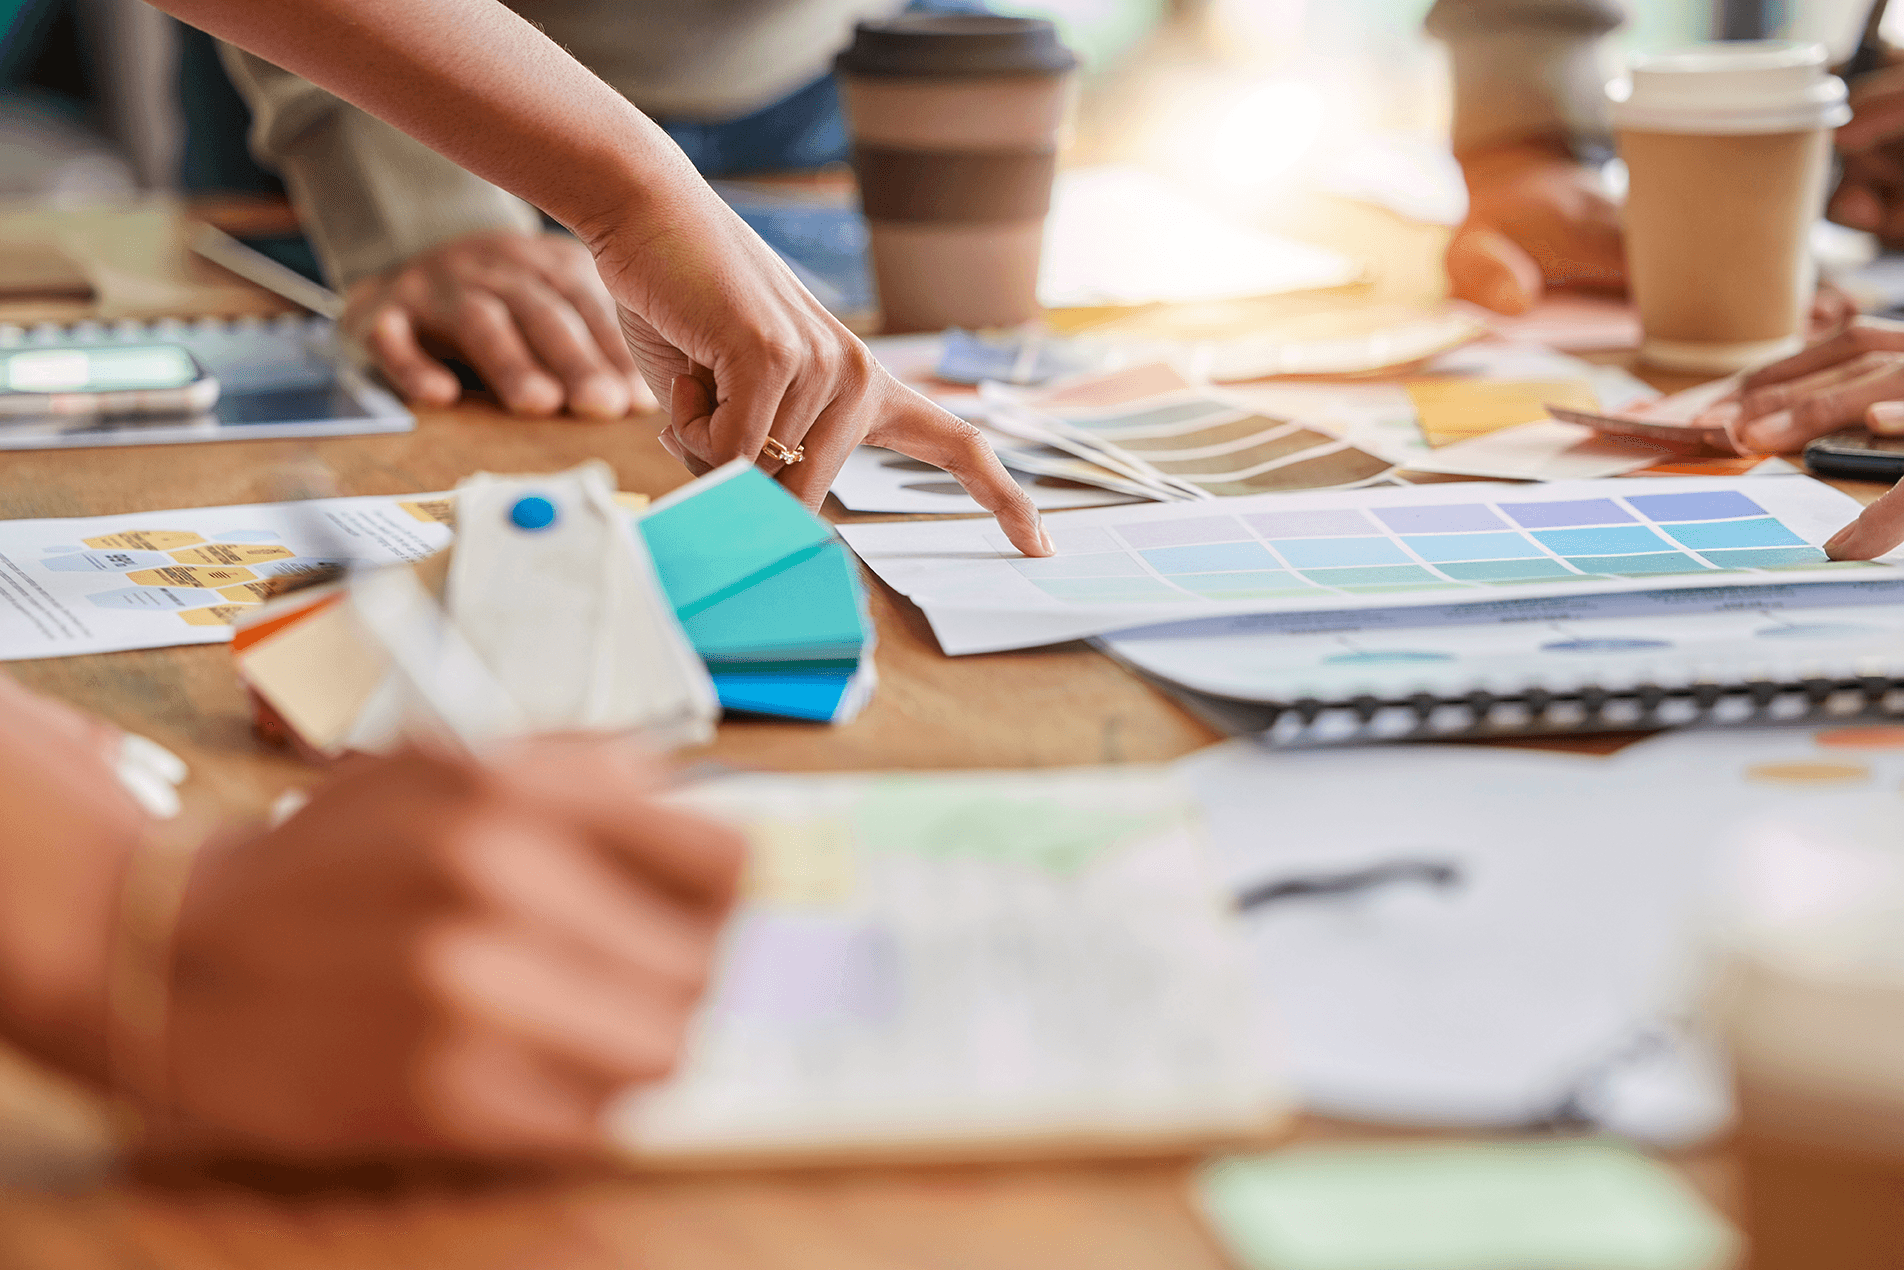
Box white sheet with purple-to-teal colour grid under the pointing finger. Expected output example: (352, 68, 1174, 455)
(842, 476, 1898, 657)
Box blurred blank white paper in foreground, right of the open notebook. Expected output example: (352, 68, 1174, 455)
(1179, 743, 1727, 1142)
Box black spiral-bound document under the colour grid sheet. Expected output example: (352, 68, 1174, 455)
(1097, 581, 1904, 746)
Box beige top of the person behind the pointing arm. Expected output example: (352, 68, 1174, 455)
(223, 0, 906, 288)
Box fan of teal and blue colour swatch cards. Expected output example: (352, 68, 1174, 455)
(636, 461, 874, 722)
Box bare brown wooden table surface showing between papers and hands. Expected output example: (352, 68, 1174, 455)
(0, 194, 1877, 1270)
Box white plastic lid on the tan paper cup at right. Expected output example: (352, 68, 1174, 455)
(1607, 40, 1851, 133)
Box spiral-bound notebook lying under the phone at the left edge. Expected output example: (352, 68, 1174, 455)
(0, 314, 417, 449)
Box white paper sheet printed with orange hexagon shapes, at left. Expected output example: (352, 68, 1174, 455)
(0, 493, 451, 661)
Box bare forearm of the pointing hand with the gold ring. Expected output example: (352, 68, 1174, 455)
(158, 0, 712, 238)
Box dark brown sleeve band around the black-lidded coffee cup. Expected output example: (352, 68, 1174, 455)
(853, 145, 1057, 225)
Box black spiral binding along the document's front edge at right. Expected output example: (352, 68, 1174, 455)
(1144, 676, 1904, 750)
